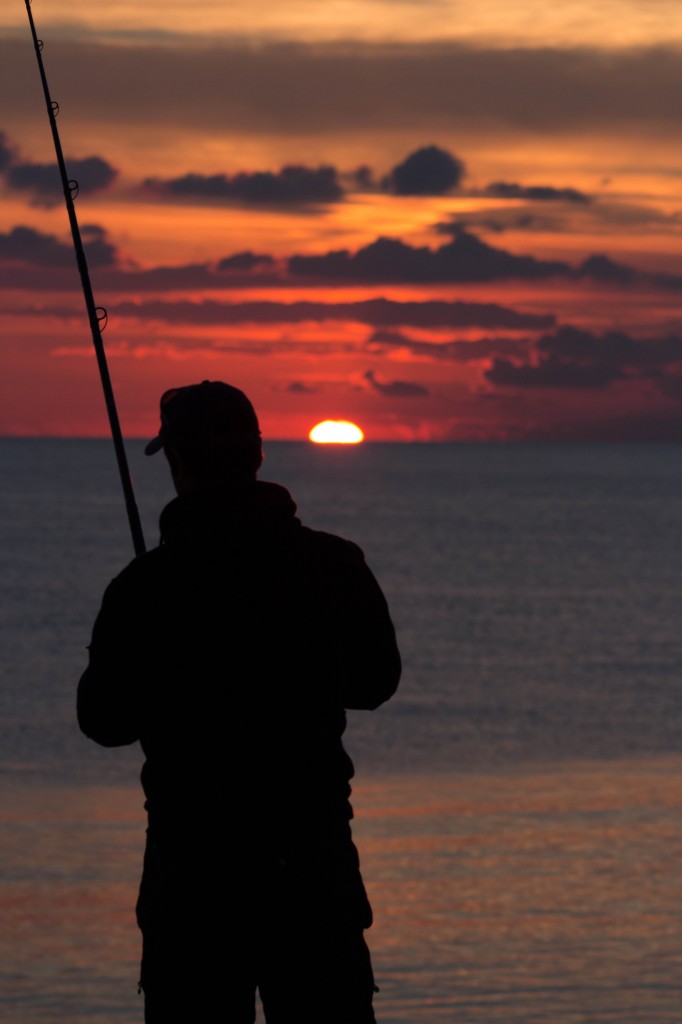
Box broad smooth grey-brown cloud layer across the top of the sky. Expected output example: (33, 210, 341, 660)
(5, 39, 682, 135)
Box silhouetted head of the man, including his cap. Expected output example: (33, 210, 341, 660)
(144, 381, 263, 490)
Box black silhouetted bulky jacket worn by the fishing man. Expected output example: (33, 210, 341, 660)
(78, 481, 400, 858)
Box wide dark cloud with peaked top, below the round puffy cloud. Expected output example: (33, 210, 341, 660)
(288, 229, 572, 284)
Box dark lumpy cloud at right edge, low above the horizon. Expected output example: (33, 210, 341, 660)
(485, 327, 682, 391)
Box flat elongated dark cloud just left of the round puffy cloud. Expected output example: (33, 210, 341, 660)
(143, 165, 344, 206)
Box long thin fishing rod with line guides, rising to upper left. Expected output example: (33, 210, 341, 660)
(26, 0, 144, 555)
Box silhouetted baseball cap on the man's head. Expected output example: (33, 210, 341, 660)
(144, 381, 260, 455)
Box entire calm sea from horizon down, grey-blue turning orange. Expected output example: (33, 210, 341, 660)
(0, 439, 682, 1024)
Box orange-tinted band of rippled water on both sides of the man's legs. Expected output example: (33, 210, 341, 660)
(2, 758, 682, 1024)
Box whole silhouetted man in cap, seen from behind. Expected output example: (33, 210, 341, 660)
(78, 381, 400, 1024)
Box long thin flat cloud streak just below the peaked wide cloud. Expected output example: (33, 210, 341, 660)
(110, 299, 554, 331)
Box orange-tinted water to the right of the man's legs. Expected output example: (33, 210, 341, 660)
(355, 759, 682, 1024)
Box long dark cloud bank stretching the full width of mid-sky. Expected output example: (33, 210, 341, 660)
(5, 216, 682, 291)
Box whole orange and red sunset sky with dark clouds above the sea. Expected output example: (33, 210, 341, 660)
(0, 0, 682, 441)
